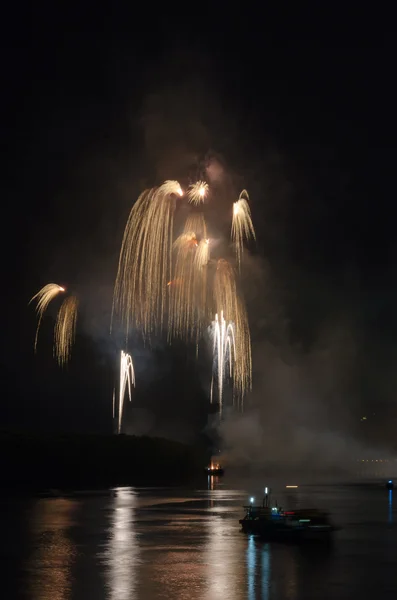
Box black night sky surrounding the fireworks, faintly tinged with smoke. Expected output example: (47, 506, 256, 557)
(0, 8, 397, 454)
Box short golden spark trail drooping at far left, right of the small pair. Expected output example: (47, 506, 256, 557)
(54, 296, 78, 367)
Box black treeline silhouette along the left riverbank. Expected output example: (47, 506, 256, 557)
(0, 432, 209, 490)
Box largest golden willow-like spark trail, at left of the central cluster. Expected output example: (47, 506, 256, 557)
(112, 181, 183, 337)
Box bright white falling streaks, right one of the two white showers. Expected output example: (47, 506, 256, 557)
(211, 312, 236, 416)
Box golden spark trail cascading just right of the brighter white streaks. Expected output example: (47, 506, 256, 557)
(214, 259, 252, 408)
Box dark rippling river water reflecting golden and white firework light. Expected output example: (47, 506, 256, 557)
(0, 476, 397, 600)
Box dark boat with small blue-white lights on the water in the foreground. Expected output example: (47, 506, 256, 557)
(239, 495, 337, 543)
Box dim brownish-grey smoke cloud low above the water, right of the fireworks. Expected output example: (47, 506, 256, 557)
(219, 324, 391, 477)
